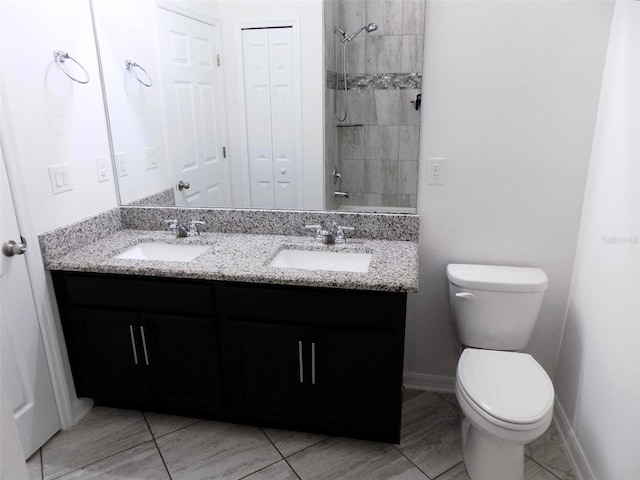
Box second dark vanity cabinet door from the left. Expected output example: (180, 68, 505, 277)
(139, 315, 220, 414)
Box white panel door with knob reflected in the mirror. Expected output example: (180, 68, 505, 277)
(158, 8, 231, 207)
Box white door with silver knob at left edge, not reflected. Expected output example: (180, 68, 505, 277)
(0, 156, 60, 458)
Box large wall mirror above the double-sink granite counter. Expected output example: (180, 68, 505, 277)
(92, 0, 424, 213)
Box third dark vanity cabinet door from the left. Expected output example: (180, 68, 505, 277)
(222, 321, 309, 427)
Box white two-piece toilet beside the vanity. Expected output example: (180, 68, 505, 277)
(447, 264, 554, 480)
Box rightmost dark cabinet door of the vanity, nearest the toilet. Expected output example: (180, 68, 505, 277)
(311, 328, 402, 442)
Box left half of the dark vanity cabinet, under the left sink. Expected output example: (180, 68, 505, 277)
(52, 272, 222, 416)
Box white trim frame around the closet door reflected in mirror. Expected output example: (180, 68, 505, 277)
(234, 19, 304, 208)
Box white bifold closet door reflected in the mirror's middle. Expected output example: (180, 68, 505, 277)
(242, 27, 298, 208)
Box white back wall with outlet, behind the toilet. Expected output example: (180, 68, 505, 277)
(405, 1, 612, 388)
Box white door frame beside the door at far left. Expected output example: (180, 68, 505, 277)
(0, 76, 93, 429)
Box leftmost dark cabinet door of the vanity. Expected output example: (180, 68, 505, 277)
(70, 308, 149, 404)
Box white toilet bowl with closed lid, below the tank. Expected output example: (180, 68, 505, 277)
(456, 348, 554, 480)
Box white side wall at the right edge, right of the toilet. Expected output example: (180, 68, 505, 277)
(555, 0, 640, 480)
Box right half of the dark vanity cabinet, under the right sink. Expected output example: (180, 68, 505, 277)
(217, 284, 406, 442)
